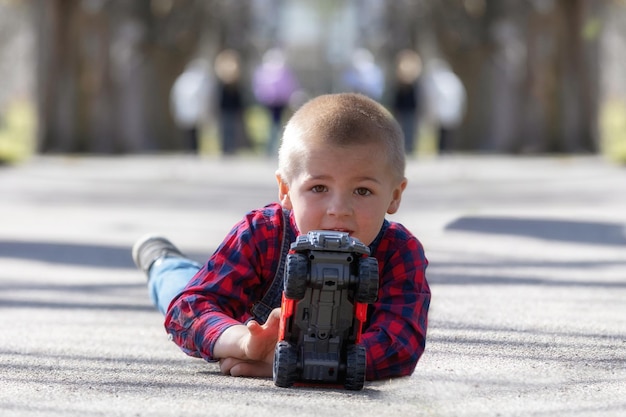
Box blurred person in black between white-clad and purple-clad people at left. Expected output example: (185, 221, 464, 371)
(215, 49, 250, 155)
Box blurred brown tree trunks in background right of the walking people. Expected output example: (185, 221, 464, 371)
(432, 0, 604, 152)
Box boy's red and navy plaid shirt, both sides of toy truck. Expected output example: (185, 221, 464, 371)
(165, 203, 430, 380)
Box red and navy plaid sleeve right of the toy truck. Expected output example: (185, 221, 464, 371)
(361, 227, 430, 380)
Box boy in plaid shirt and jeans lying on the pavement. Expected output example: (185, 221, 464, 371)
(133, 93, 430, 380)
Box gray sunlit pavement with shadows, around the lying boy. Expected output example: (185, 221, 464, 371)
(0, 155, 626, 417)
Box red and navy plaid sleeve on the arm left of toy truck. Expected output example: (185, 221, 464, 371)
(165, 210, 279, 361)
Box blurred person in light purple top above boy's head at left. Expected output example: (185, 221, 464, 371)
(252, 48, 298, 155)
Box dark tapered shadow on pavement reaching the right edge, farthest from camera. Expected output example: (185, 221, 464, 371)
(445, 216, 626, 246)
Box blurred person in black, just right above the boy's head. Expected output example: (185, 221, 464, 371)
(392, 49, 422, 155)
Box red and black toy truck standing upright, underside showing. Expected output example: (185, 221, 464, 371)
(273, 230, 378, 390)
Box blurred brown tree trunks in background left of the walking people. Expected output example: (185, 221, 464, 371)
(34, 0, 205, 153)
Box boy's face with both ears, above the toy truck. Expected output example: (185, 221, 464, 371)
(277, 143, 406, 245)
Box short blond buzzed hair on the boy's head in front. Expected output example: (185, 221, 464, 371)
(278, 93, 406, 182)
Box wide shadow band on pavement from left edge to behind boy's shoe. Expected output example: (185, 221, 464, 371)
(0, 240, 209, 269)
